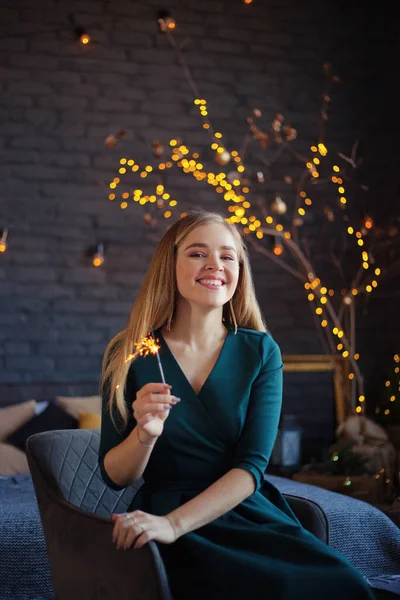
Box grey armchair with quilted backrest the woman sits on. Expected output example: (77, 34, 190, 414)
(26, 429, 328, 600)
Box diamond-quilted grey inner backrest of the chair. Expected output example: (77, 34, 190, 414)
(27, 429, 140, 518)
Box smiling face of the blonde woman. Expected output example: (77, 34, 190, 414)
(176, 223, 239, 308)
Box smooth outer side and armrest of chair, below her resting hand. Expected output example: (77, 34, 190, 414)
(27, 438, 172, 600)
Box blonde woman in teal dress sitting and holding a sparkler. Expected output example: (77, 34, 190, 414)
(100, 212, 373, 600)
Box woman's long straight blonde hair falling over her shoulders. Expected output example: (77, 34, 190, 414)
(100, 211, 267, 425)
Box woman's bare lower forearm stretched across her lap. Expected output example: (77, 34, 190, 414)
(167, 468, 255, 537)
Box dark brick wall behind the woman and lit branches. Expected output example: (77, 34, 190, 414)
(0, 0, 391, 462)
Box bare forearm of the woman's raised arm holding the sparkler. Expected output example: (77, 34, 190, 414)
(104, 427, 157, 486)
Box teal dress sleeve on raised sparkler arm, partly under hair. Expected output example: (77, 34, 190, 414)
(98, 370, 136, 491)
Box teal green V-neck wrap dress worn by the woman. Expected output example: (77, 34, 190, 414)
(99, 328, 374, 600)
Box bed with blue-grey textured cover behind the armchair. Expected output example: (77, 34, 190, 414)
(0, 475, 400, 600)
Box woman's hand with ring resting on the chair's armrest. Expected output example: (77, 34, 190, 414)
(111, 510, 177, 550)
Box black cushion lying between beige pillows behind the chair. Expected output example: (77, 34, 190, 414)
(7, 404, 78, 450)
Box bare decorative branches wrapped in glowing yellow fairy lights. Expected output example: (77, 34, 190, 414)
(104, 22, 400, 413)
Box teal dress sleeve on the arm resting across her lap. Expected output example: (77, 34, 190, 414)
(233, 334, 283, 490)
